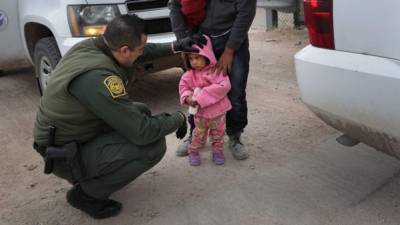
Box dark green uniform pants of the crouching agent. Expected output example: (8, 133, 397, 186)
(54, 132, 166, 198)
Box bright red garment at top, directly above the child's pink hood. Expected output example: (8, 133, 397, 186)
(181, 0, 207, 33)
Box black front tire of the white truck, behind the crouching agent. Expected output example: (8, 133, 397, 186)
(33, 37, 61, 95)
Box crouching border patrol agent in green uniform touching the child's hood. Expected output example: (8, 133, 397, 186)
(33, 15, 205, 219)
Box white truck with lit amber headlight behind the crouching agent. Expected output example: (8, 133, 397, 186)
(0, 0, 180, 91)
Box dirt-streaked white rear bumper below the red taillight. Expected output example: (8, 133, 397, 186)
(295, 46, 400, 159)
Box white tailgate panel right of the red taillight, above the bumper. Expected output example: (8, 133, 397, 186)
(333, 0, 400, 60)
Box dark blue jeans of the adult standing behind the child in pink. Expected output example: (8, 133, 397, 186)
(211, 33, 250, 137)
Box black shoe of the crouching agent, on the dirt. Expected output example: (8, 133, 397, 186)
(67, 185, 122, 219)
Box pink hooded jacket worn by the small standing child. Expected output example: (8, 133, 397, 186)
(179, 36, 232, 119)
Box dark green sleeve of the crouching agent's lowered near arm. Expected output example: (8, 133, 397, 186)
(69, 70, 183, 145)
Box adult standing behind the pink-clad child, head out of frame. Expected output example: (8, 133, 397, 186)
(168, 0, 257, 160)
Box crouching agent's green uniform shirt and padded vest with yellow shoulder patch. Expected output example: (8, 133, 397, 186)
(33, 38, 183, 145)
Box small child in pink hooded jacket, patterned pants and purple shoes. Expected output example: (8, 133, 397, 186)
(179, 37, 232, 166)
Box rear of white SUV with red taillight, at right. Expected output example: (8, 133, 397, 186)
(295, 0, 400, 158)
